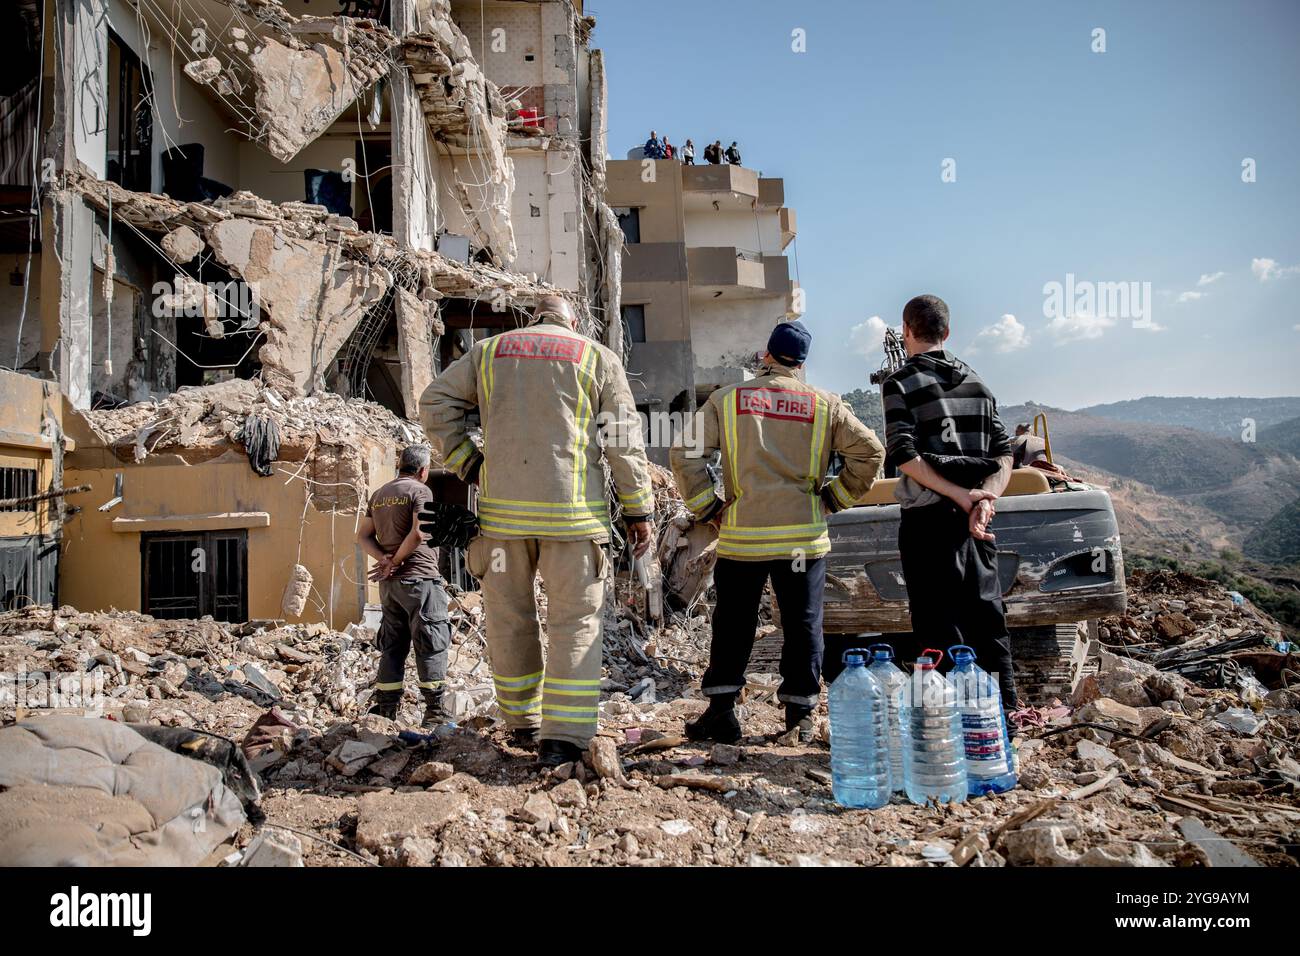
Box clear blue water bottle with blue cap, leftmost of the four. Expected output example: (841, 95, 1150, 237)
(827, 648, 893, 810)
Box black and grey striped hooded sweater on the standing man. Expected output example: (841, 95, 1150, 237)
(880, 349, 1011, 507)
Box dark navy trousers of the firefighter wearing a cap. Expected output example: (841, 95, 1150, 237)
(702, 557, 826, 708)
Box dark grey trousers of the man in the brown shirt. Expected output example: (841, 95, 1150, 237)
(374, 578, 451, 698)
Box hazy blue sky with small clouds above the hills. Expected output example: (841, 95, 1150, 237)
(586, 0, 1300, 407)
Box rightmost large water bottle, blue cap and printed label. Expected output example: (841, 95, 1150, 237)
(948, 644, 1017, 796)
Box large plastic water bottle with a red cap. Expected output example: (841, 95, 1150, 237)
(898, 648, 966, 806)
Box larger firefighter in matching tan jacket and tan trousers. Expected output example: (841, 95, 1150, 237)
(420, 295, 653, 766)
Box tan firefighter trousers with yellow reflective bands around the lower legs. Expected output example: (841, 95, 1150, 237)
(465, 536, 608, 748)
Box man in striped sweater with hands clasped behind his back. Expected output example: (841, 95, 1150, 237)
(880, 295, 1017, 710)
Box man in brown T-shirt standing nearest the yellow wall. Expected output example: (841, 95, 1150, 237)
(356, 445, 451, 727)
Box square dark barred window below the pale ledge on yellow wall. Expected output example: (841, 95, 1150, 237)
(140, 531, 248, 623)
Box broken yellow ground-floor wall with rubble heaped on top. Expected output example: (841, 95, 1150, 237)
(61, 381, 423, 624)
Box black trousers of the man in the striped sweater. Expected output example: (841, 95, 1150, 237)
(899, 501, 1017, 711)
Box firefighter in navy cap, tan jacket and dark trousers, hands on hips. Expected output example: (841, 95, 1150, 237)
(672, 321, 884, 743)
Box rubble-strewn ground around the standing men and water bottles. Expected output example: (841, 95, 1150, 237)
(0, 576, 1300, 866)
